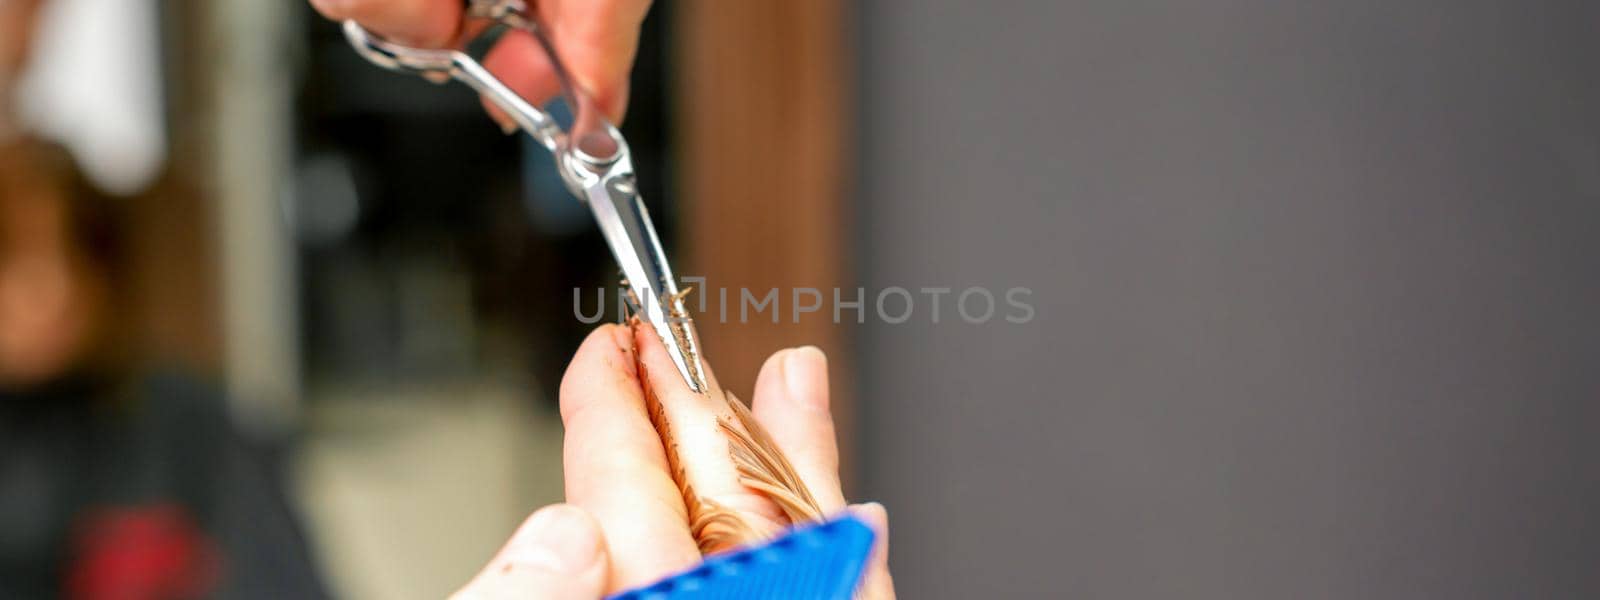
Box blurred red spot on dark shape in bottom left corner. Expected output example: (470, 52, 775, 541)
(64, 504, 219, 600)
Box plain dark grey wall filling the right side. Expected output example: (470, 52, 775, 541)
(858, 0, 1600, 598)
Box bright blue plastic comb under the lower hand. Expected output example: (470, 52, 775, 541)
(610, 515, 872, 600)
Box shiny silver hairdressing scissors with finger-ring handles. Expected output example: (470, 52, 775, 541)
(344, 0, 706, 392)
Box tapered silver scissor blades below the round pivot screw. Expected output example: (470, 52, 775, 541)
(572, 158, 706, 392)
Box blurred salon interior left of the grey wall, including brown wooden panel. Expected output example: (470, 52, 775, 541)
(0, 0, 850, 598)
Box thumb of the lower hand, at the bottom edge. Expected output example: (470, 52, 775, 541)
(451, 504, 606, 600)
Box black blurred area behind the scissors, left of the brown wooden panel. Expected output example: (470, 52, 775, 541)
(290, 5, 674, 398)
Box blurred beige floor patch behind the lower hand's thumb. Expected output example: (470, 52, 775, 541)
(296, 379, 562, 600)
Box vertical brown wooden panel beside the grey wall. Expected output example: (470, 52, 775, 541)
(672, 0, 856, 485)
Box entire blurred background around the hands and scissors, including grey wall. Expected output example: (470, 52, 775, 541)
(9, 0, 1600, 598)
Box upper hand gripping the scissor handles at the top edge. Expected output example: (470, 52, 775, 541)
(310, 0, 650, 126)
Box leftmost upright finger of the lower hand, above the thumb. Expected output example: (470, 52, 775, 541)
(562, 325, 701, 592)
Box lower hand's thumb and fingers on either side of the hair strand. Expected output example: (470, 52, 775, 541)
(458, 325, 894, 600)
